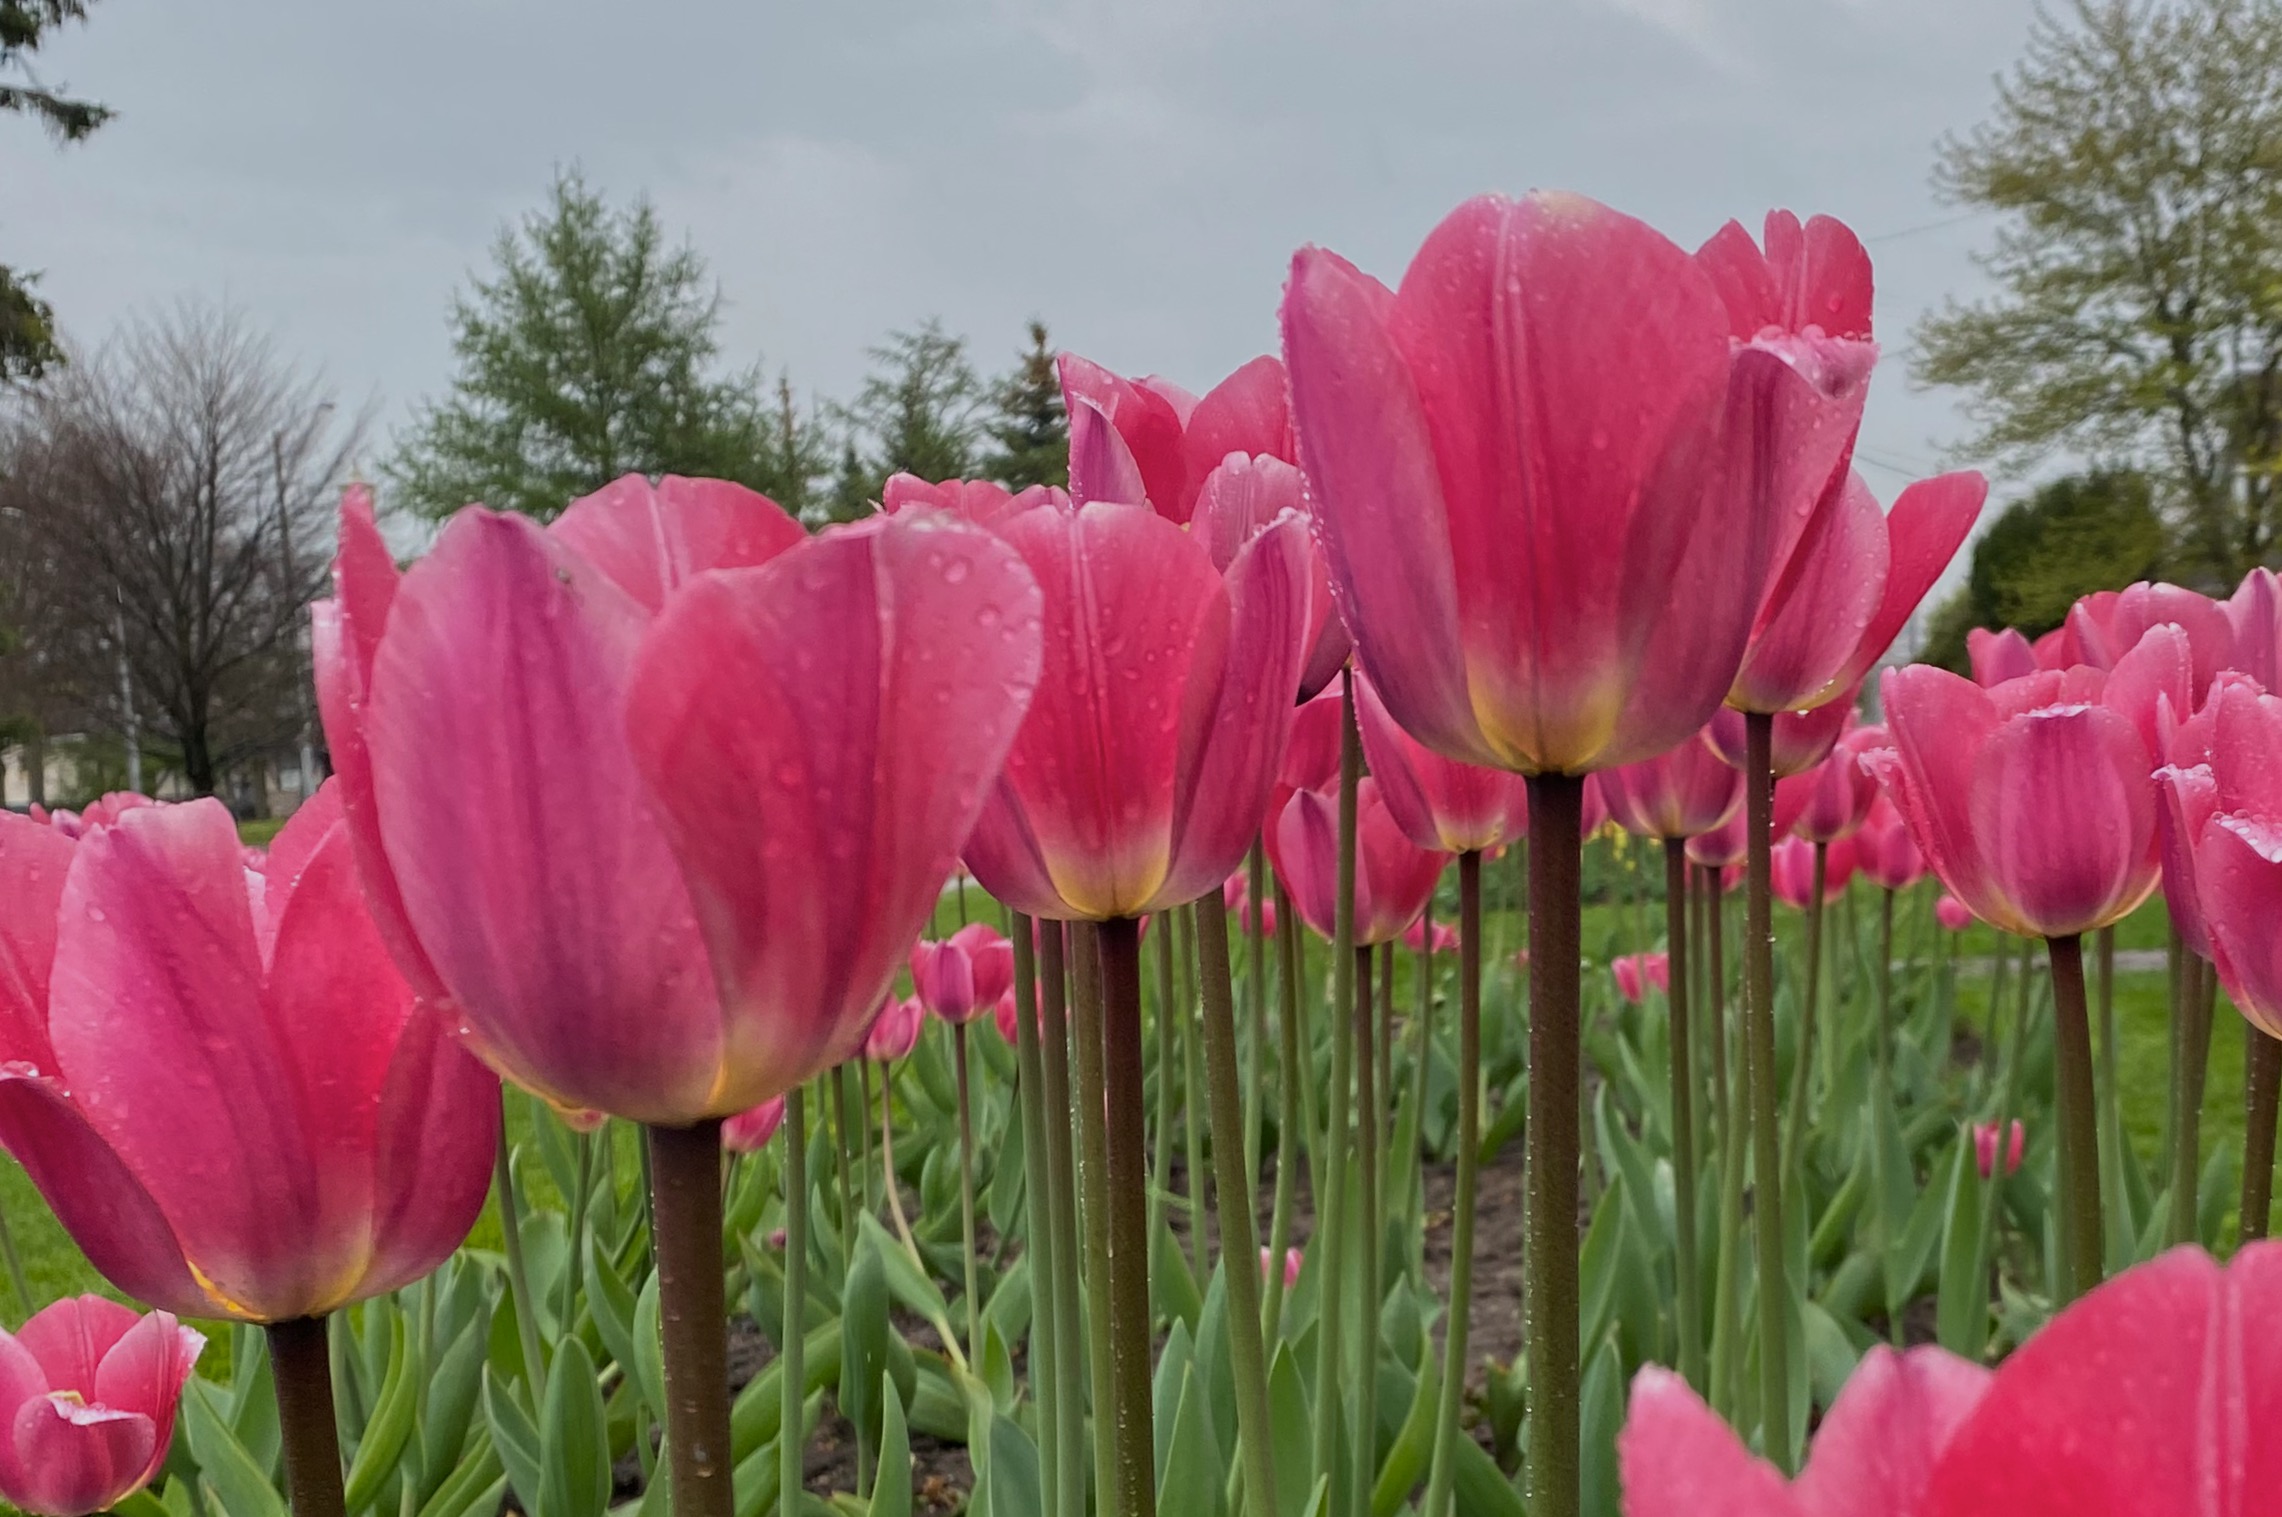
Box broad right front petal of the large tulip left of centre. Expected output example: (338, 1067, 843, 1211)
(628, 506, 1045, 1116)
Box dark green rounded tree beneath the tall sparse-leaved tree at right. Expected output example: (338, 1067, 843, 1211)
(1921, 472, 2163, 671)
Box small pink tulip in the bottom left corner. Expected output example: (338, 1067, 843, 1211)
(0, 1296, 205, 1517)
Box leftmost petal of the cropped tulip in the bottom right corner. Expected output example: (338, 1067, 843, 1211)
(1616, 1366, 1803, 1517)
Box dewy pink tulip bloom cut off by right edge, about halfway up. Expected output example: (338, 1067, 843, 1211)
(2156, 680, 2282, 1036)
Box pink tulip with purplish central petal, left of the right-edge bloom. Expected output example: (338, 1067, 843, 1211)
(1862, 625, 2193, 938)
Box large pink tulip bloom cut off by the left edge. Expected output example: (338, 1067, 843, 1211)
(0, 782, 500, 1323)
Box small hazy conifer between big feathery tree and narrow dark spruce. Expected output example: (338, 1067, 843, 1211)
(831, 317, 988, 520)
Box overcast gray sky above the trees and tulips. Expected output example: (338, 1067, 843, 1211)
(0, 0, 2031, 508)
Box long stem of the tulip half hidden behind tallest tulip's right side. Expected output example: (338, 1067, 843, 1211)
(1743, 712, 1791, 1474)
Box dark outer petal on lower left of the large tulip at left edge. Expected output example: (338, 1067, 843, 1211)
(0, 1065, 205, 1316)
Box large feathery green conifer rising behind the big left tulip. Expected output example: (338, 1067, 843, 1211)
(388, 171, 822, 518)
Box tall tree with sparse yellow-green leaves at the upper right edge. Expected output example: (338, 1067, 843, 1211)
(1917, 0, 2282, 586)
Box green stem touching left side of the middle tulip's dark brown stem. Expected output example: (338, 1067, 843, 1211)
(1068, 922, 1127, 1517)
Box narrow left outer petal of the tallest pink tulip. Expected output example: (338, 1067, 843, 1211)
(1282, 249, 1497, 764)
